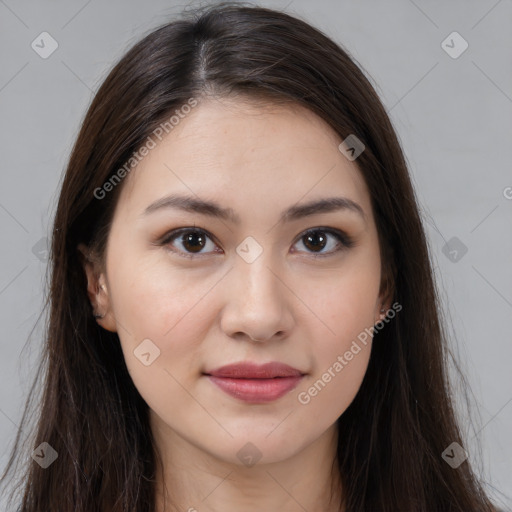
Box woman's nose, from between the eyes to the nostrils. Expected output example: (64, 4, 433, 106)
(221, 251, 294, 342)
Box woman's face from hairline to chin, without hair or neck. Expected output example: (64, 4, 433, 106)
(80, 99, 389, 464)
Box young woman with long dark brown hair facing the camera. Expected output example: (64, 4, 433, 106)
(0, 4, 495, 512)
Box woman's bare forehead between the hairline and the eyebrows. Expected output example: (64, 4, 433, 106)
(118, 98, 370, 222)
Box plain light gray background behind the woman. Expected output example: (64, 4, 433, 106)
(0, 0, 512, 510)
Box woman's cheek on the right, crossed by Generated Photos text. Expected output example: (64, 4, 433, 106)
(297, 254, 380, 423)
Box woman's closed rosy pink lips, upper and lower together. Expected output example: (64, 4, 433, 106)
(205, 362, 305, 403)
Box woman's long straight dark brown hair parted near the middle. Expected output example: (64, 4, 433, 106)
(4, 3, 500, 512)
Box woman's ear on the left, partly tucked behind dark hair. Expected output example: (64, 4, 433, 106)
(77, 243, 117, 332)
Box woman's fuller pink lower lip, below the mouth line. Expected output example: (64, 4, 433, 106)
(208, 375, 303, 403)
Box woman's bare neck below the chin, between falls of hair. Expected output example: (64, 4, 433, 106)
(154, 424, 342, 512)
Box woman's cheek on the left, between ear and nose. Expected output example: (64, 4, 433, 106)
(108, 265, 218, 394)
